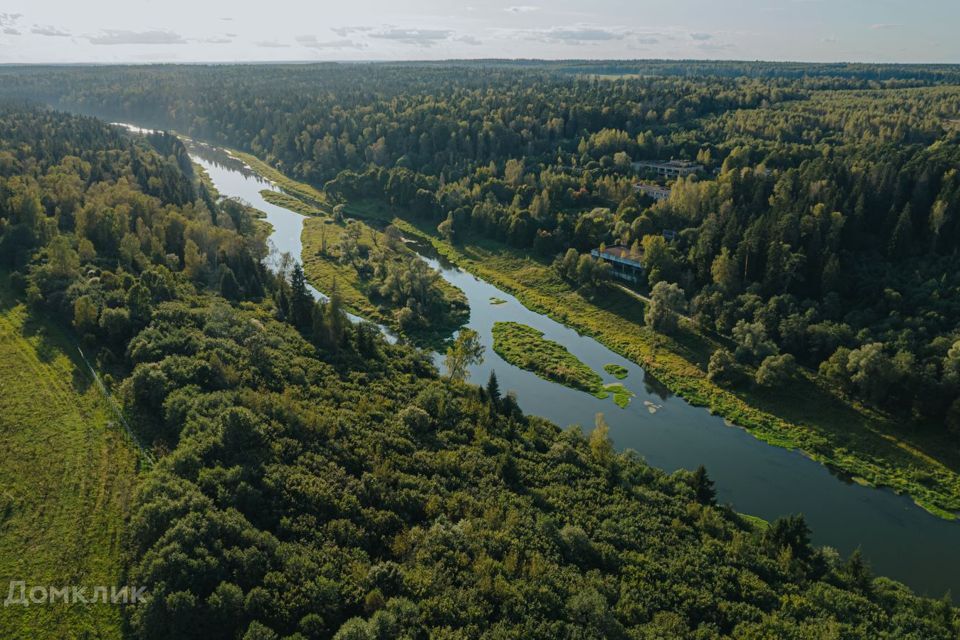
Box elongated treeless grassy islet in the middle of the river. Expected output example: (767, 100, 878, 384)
(493, 322, 607, 397)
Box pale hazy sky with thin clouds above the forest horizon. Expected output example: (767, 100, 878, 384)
(0, 0, 960, 63)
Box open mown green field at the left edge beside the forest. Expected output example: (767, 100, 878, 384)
(0, 276, 137, 639)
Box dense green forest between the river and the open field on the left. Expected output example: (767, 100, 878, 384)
(0, 95, 957, 640)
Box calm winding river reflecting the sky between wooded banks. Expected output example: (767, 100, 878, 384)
(182, 136, 960, 597)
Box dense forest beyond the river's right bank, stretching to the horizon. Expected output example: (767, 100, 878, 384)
(3, 61, 960, 434)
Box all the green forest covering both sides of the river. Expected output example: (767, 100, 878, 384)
(0, 64, 960, 640)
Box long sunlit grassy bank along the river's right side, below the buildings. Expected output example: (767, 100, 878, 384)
(236, 155, 960, 518)
